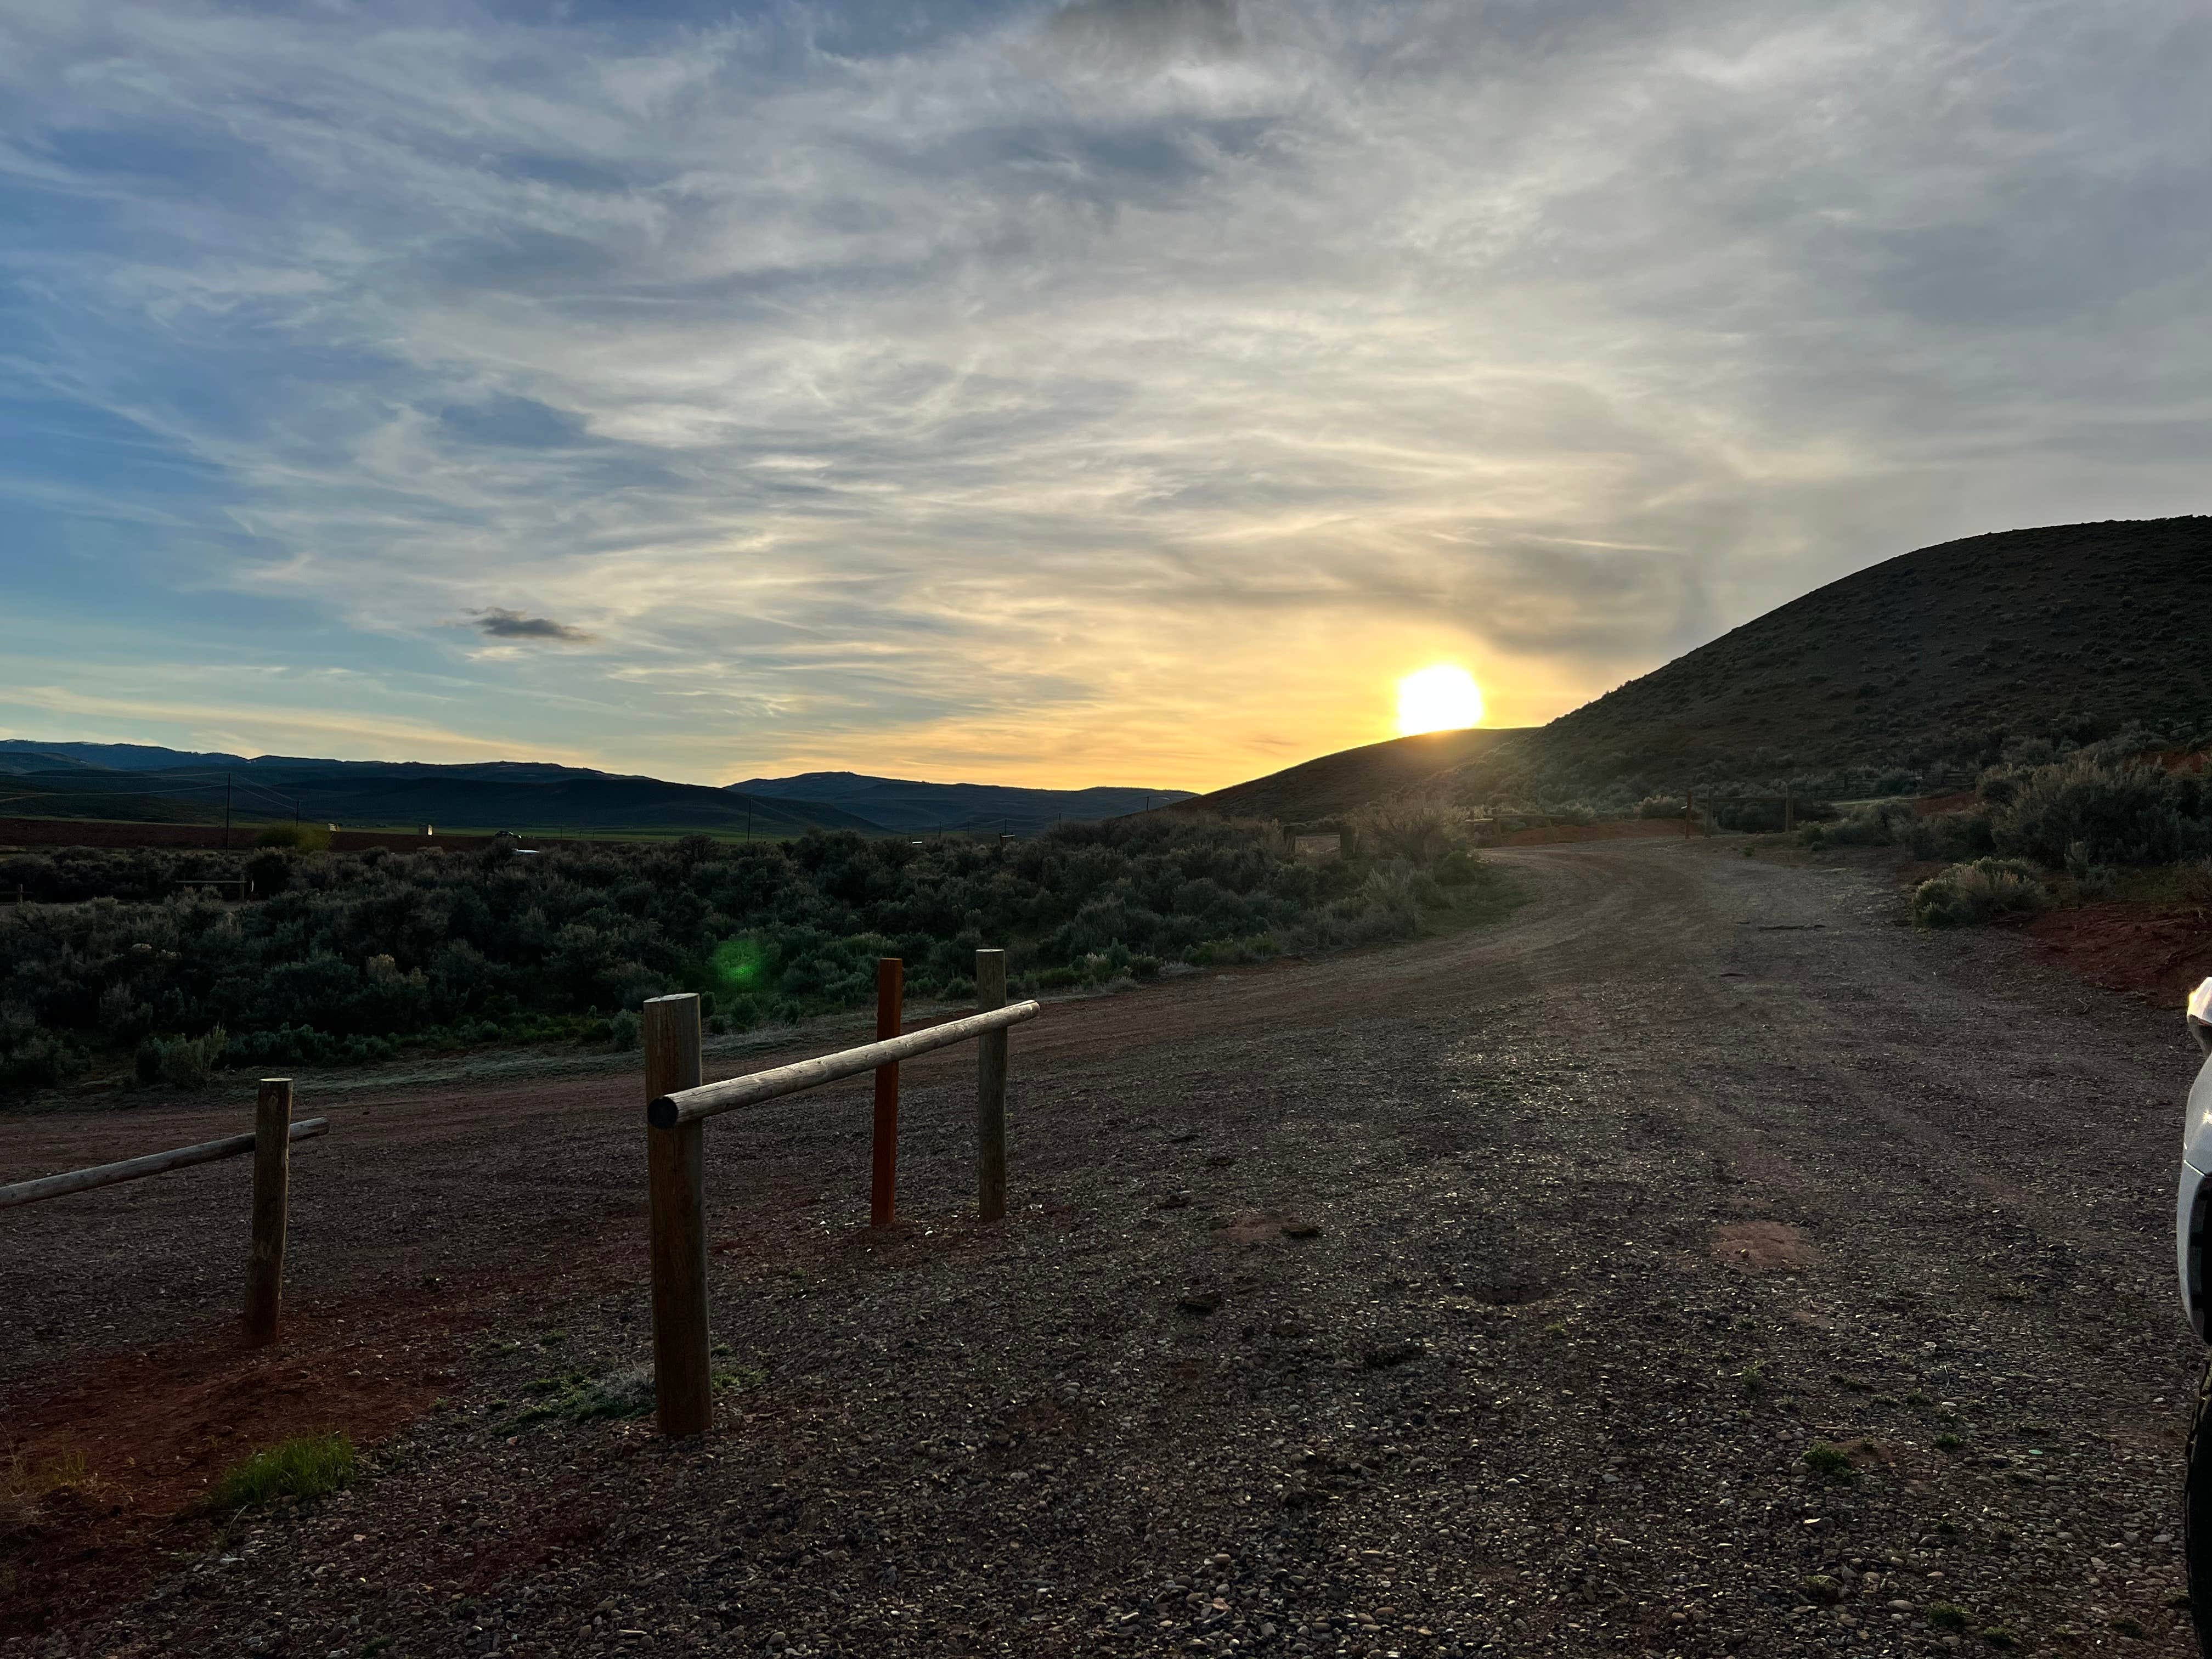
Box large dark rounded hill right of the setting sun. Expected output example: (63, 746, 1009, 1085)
(1451, 517, 2212, 797)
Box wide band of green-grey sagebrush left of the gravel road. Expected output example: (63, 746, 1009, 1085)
(0, 805, 1504, 1084)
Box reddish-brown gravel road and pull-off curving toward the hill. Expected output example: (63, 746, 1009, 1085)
(0, 840, 2194, 1659)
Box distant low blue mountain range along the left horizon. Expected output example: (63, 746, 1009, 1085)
(0, 739, 1188, 836)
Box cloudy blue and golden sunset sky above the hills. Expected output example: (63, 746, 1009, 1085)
(0, 0, 2212, 789)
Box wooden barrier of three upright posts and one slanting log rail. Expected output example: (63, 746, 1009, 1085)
(644, 951, 1042, 1436)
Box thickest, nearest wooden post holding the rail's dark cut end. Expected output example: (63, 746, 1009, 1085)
(639, 993, 714, 1436)
